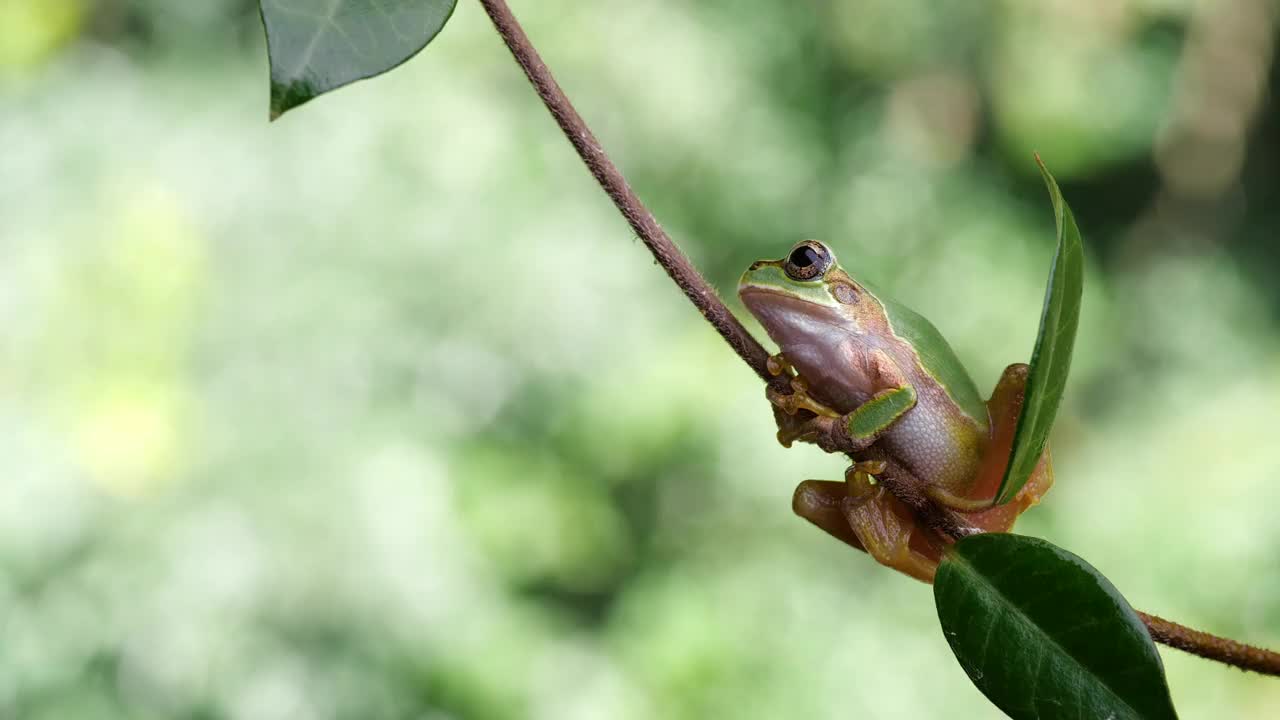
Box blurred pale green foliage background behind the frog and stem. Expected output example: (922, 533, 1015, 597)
(0, 0, 1280, 720)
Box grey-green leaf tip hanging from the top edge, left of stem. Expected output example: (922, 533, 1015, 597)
(260, 0, 457, 120)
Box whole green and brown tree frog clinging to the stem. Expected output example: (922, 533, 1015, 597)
(737, 240, 1053, 583)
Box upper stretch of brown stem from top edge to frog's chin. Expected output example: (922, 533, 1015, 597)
(480, 0, 772, 382)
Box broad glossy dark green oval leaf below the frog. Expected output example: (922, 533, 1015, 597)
(933, 533, 1178, 720)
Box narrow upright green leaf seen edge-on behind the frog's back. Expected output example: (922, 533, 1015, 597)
(996, 156, 1084, 503)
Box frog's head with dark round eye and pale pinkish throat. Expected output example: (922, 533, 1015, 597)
(737, 240, 874, 352)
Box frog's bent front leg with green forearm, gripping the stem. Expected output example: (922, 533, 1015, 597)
(765, 350, 916, 454)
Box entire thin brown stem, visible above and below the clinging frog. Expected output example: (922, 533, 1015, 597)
(480, 0, 1280, 675)
